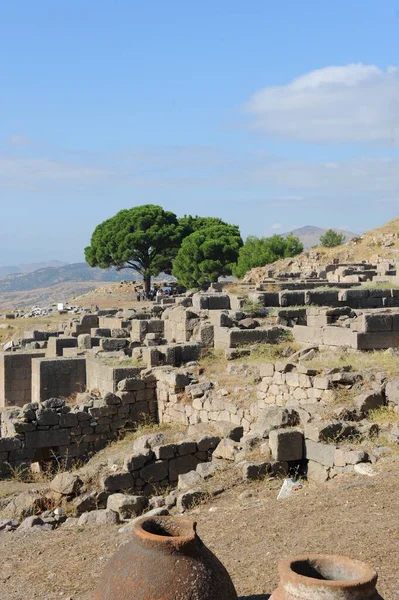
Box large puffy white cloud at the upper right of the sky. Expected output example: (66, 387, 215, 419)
(245, 63, 399, 146)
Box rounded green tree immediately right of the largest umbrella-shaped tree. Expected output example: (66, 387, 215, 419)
(172, 224, 242, 288)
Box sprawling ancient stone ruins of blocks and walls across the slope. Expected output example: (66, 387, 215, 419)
(0, 276, 399, 522)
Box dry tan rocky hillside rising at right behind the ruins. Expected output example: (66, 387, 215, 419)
(244, 218, 399, 283)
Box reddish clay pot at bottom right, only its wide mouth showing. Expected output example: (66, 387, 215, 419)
(270, 554, 382, 600)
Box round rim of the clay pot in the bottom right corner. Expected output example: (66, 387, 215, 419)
(278, 554, 378, 590)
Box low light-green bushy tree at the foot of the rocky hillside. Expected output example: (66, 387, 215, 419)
(233, 234, 303, 278)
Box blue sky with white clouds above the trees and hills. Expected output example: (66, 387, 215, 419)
(0, 0, 399, 265)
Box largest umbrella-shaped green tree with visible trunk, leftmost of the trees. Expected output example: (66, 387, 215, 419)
(85, 204, 182, 293)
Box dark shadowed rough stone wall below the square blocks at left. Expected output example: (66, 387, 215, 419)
(0, 377, 157, 473)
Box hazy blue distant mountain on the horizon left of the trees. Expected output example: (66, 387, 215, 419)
(0, 263, 139, 293)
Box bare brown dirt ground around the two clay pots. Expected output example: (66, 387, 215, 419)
(0, 457, 399, 600)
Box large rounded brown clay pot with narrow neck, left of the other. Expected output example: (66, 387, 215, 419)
(94, 516, 237, 600)
